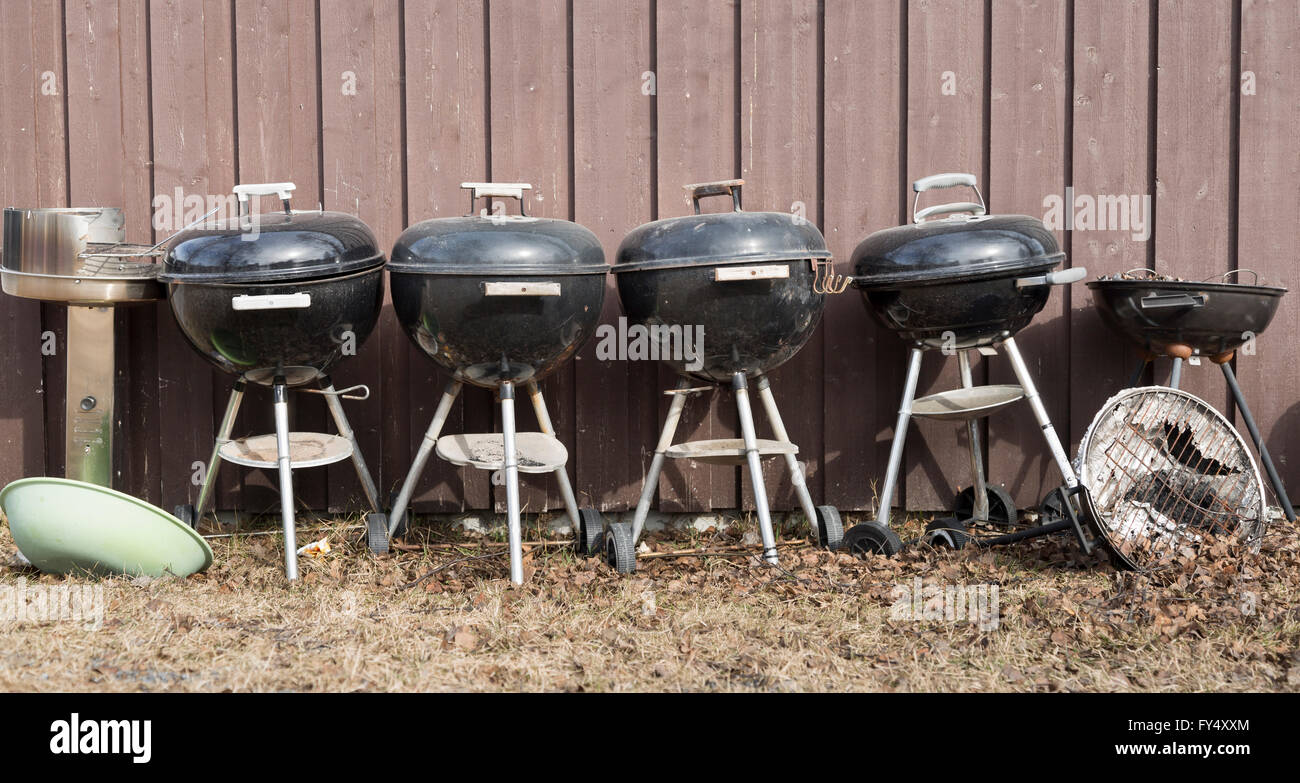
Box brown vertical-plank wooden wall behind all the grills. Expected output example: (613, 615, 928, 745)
(0, 0, 1300, 511)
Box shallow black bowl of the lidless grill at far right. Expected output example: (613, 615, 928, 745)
(1088, 280, 1287, 356)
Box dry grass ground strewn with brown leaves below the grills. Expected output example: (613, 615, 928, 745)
(0, 512, 1300, 692)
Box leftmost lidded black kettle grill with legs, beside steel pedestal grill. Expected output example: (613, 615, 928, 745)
(159, 182, 384, 572)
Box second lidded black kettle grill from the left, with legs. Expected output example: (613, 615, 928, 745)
(368, 182, 608, 584)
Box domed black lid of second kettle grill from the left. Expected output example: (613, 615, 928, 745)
(389, 182, 610, 277)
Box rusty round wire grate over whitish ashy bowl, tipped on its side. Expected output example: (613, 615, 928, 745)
(1075, 386, 1268, 571)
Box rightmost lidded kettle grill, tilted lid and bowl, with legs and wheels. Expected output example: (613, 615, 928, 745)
(844, 174, 1087, 554)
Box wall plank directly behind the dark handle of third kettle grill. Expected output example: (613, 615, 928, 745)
(655, 0, 740, 511)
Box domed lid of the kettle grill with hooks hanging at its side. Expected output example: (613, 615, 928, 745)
(614, 179, 831, 273)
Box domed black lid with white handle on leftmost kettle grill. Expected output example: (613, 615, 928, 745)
(159, 182, 384, 284)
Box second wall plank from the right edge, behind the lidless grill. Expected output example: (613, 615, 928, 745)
(1154, 0, 1238, 410)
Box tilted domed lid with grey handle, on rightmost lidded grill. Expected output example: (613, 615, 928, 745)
(853, 174, 1065, 289)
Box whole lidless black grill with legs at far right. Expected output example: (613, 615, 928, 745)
(1088, 268, 1296, 522)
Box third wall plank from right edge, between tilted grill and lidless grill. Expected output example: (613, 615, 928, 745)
(1056, 0, 1154, 447)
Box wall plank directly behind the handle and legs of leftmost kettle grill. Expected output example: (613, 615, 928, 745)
(233, 0, 327, 510)
